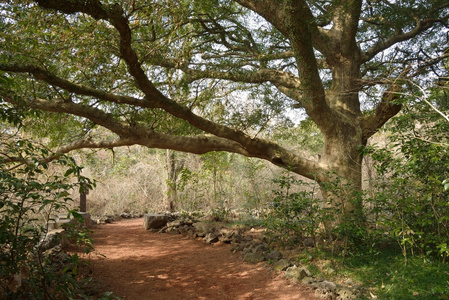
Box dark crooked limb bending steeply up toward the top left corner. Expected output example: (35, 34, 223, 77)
(28, 0, 325, 177)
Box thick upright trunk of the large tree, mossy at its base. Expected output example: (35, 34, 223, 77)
(318, 56, 366, 224)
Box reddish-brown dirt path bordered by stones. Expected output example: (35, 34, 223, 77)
(92, 219, 316, 300)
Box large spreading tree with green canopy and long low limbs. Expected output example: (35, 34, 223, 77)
(0, 0, 449, 220)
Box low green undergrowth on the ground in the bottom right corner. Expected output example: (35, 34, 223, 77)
(296, 248, 449, 300)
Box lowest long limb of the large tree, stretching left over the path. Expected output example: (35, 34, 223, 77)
(2, 85, 324, 179)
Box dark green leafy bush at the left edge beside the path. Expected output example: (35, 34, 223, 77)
(0, 139, 92, 299)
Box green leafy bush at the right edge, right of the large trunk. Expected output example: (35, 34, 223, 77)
(364, 140, 449, 259)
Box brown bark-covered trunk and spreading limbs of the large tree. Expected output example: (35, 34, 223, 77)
(0, 0, 442, 230)
